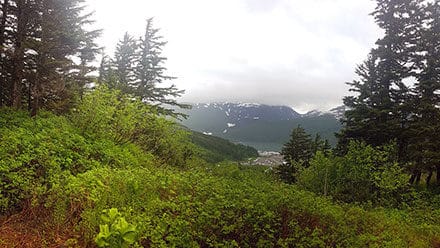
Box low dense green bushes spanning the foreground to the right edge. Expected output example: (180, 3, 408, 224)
(45, 164, 440, 247)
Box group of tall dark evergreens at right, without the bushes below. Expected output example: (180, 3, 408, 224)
(338, 0, 440, 185)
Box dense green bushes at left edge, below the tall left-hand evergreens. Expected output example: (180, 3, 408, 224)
(0, 109, 153, 213)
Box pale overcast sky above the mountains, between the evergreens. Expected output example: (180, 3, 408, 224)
(87, 0, 381, 112)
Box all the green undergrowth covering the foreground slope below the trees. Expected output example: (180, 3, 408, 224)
(0, 88, 440, 247)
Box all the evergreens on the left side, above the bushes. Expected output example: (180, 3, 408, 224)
(0, 0, 189, 116)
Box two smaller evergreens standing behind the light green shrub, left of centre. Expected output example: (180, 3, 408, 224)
(98, 18, 190, 116)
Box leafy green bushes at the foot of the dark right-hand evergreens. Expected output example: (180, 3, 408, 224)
(298, 142, 409, 205)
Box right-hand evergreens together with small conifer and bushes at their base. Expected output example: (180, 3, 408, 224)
(276, 0, 440, 203)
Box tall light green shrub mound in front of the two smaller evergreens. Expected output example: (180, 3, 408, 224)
(71, 86, 193, 166)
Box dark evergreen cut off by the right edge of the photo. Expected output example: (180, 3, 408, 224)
(408, 1, 440, 185)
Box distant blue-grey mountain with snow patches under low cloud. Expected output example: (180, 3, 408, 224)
(177, 102, 340, 151)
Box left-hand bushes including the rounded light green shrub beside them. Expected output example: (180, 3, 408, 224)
(0, 88, 192, 213)
